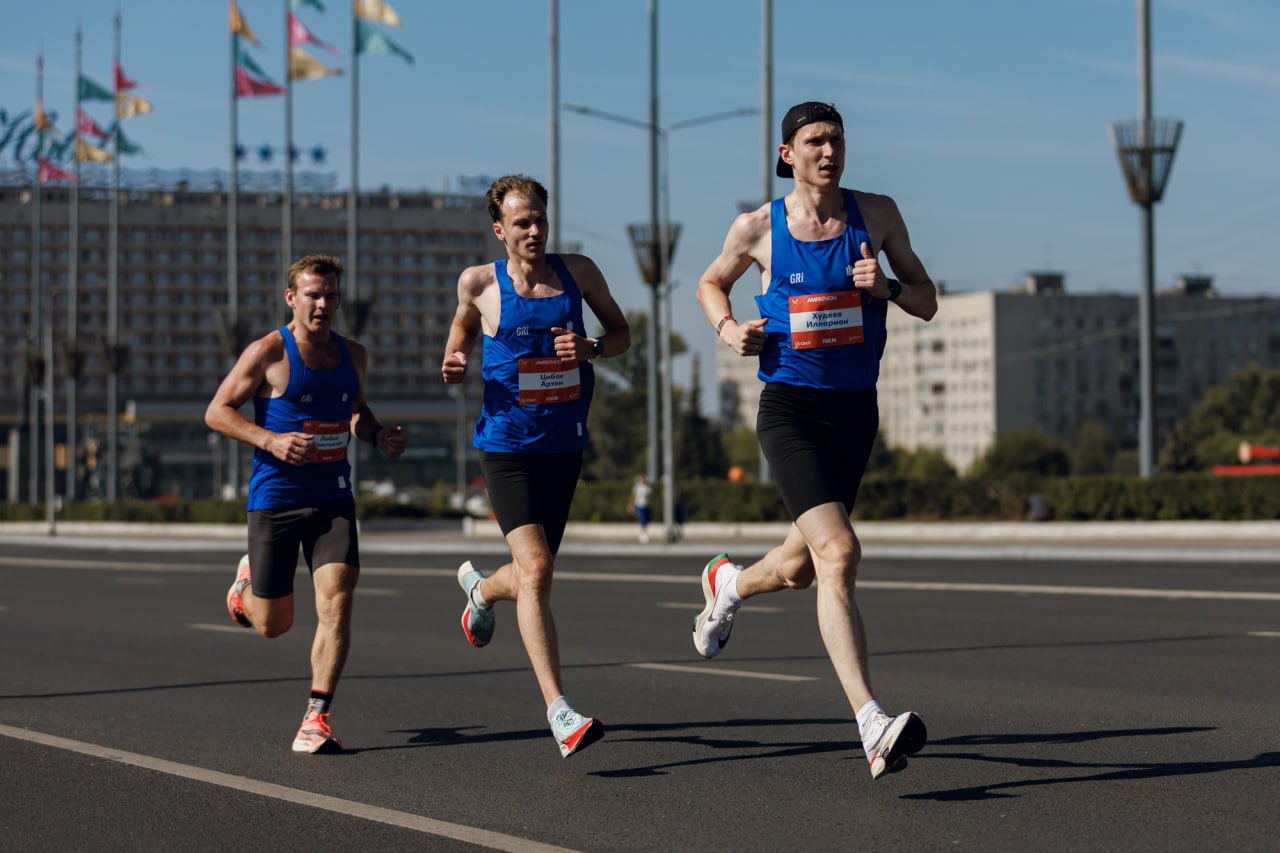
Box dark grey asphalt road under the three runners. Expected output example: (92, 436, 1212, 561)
(0, 543, 1280, 850)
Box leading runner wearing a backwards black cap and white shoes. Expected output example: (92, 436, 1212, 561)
(694, 101, 937, 779)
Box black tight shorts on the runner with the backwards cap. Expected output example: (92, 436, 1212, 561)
(755, 383, 879, 521)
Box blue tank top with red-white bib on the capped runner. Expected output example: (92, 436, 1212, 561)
(755, 190, 888, 391)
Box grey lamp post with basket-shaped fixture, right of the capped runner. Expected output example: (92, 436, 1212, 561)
(1110, 0, 1183, 476)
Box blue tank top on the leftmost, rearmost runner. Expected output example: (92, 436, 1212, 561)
(247, 327, 360, 512)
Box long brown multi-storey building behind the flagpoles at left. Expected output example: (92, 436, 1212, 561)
(0, 174, 497, 500)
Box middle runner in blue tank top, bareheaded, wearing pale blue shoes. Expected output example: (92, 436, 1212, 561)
(440, 175, 631, 758)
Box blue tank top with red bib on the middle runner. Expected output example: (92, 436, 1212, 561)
(471, 255, 595, 453)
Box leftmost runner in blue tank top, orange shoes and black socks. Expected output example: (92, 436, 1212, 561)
(205, 255, 407, 753)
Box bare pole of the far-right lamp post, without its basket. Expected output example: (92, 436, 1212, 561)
(1138, 0, 1156, 476)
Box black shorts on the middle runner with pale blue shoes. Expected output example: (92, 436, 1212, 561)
(480, 451, 582, 553)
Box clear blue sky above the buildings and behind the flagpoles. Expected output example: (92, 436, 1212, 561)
(0, 0, 1280, 397)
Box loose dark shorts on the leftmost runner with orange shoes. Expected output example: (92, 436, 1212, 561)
(248, 498, 360, 598)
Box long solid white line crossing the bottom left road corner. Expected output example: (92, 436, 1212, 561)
(0, 724, 568, 853)
